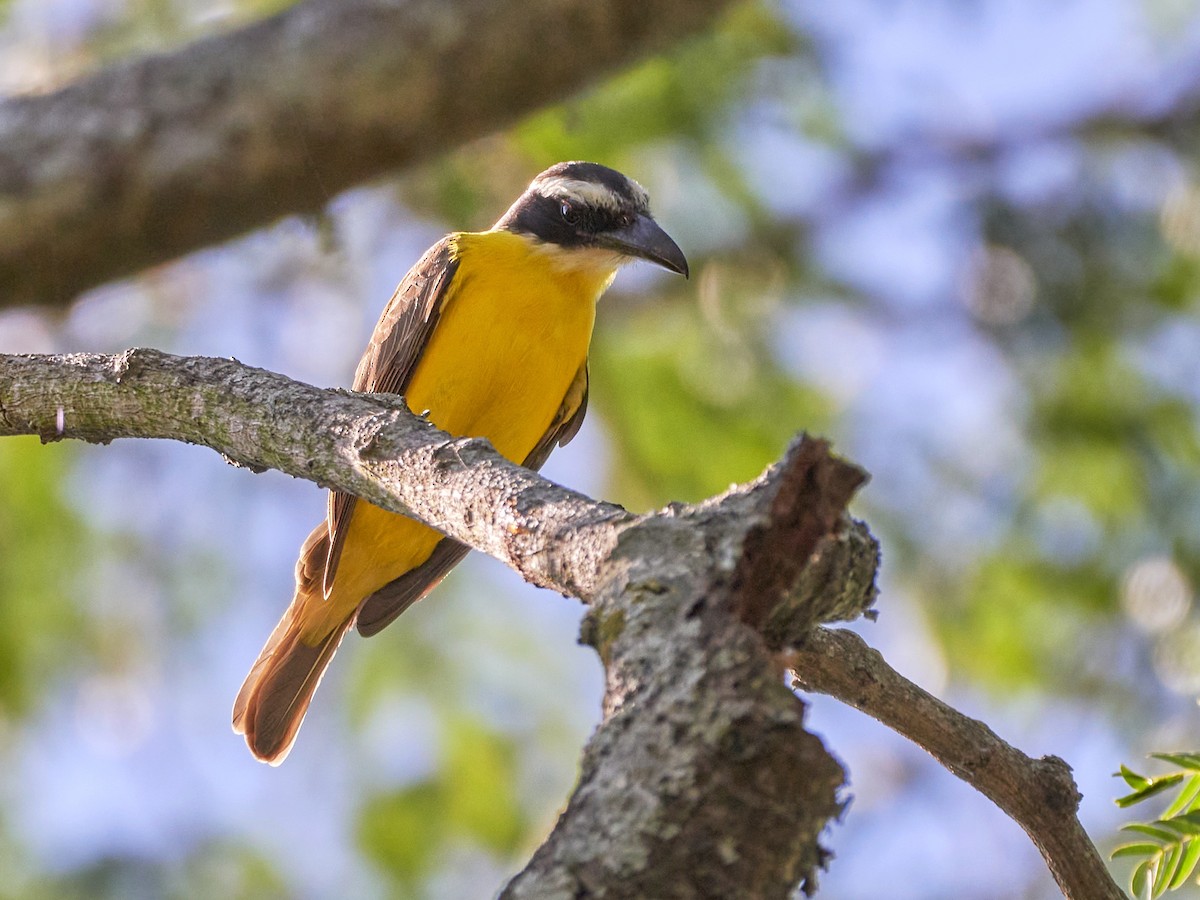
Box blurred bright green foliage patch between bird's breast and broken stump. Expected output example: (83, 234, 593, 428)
(592, 282, 829, 509)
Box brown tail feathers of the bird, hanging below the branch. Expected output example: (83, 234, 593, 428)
(233, 607, 354, 766)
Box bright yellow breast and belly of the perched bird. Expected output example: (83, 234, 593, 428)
(305, 232, 614, 640)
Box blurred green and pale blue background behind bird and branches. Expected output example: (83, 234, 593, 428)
(0, 0, 1200, 900)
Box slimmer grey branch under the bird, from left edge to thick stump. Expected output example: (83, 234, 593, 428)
(0, 349, 632, 599)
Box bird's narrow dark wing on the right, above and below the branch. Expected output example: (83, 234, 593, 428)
(358, 362, 588, 637)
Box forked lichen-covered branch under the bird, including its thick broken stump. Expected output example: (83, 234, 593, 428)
(0, 350, 876, 898)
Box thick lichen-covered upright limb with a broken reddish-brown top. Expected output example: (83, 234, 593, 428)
(502, 439, 864, 900)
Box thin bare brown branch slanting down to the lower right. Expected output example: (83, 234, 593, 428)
(791, 628, 1126, 900)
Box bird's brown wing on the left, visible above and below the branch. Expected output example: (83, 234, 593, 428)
(323, 236, 458, 596)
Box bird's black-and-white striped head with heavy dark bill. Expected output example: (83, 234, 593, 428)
(494, 162, 688, 277)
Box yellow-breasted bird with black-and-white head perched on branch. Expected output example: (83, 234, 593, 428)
(233, 162, 688, 766)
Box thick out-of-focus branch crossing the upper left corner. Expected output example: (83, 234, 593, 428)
(0, 0, 730, 306)
